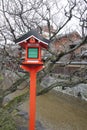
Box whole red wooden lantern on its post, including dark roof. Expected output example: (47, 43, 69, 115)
(15, 30, 49, 130)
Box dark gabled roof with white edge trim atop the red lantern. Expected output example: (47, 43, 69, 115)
(15, 30, 50, 46)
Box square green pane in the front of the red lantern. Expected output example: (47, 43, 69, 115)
(28, 48, 38, 58)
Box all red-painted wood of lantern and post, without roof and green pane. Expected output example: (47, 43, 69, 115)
(19, 37, 48, 130)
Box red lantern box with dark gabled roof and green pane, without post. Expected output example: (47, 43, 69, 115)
(16, 30, 49, 66)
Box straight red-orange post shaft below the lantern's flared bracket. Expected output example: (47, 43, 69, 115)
(29, 69, 36, 130)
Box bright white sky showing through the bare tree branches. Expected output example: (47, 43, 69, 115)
(0, 0, 86, 39)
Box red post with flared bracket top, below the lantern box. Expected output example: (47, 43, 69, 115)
(21, 64, 44, 130)
